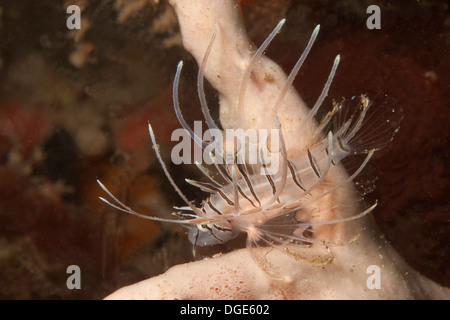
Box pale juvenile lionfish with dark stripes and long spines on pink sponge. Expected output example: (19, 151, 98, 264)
(98, 19, 398, 278)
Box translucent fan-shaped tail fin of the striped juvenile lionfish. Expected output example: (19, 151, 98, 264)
(333, 95, 403, 154)
